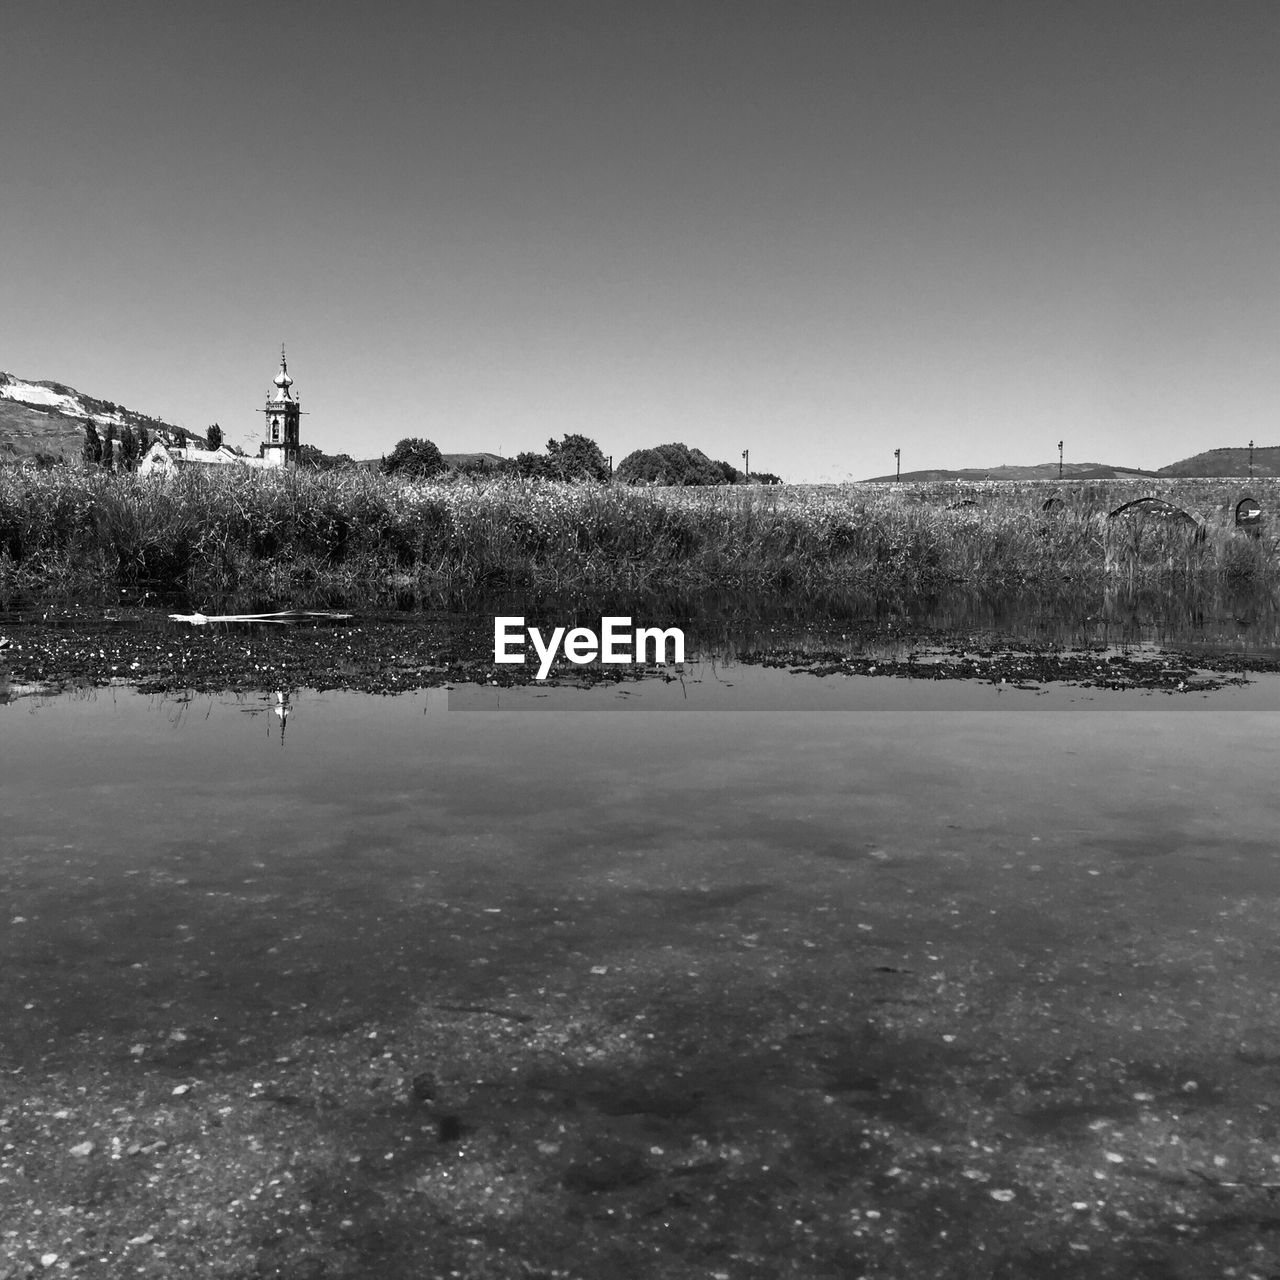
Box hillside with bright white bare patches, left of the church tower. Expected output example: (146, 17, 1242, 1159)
(0, 372, 189, 462)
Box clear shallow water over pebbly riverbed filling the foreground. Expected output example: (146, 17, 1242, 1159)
(0, 669, 1280, 1277)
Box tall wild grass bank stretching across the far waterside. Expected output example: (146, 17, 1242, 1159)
(0, 468, 1280, 596)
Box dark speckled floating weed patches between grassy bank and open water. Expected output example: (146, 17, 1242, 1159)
(0, 607, 1280, 696)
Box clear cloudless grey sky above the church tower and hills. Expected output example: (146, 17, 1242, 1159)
(0, 0, 1280, 480)
